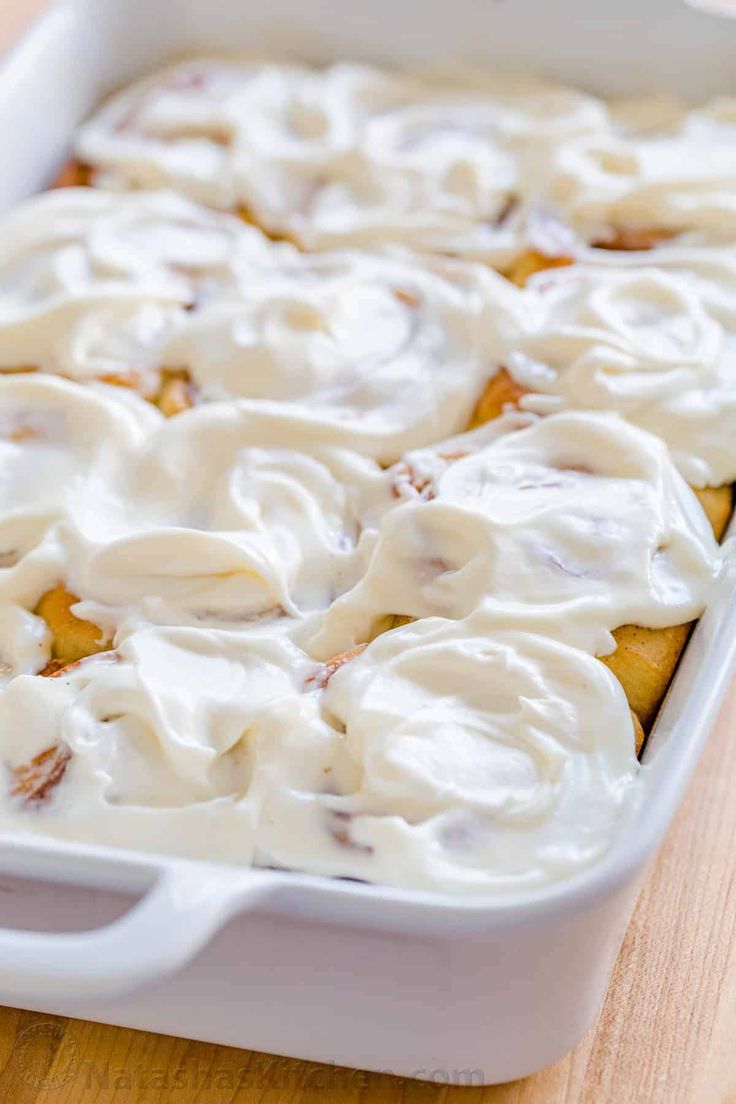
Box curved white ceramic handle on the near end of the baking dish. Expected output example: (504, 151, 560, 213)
(0, 866, 262, 1002)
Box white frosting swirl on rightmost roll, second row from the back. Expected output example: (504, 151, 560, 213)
(516, 258, 736, 486)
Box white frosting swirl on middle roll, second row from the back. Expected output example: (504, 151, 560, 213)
(161, 253, 518, 463)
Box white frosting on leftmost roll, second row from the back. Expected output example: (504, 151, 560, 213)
(0, 189, 273, 378)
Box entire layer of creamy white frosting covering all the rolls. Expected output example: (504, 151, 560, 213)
(0, 59, 736, 896)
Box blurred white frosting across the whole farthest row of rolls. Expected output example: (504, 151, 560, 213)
(76, 57, 736, 259)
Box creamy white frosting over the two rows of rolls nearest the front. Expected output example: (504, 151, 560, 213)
(0, 395, 697, 893)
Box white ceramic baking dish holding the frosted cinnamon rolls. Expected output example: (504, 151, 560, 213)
(0, 0, 736, 1084)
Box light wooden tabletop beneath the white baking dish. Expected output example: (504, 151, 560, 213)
(0, 0, 736, 1104)
